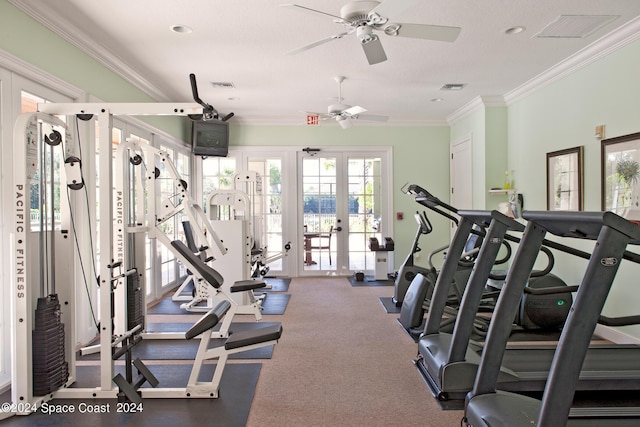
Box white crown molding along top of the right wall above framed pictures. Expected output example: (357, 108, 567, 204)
(504, 16, 640, 105)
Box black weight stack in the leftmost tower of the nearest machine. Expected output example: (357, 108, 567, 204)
(32, 294, 69, 396)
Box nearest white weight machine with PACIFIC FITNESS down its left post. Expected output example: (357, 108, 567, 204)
(11, 103, 280, 415)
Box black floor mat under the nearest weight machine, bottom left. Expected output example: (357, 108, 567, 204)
(2, 363, 262, 427)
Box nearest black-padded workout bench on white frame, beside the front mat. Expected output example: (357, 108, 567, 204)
(185, 300, 282, 398)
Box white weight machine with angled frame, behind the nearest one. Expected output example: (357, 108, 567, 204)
(116, 141, 264, 320)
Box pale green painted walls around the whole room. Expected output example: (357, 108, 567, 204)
(5, 1, 640, 337)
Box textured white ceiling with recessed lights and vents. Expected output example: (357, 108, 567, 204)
(10, 0, 640, 126)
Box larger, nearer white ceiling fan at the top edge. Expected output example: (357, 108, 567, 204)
(281, 0, 461, 65)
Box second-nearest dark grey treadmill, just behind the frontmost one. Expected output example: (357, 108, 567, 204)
(415, 211, 640, 409)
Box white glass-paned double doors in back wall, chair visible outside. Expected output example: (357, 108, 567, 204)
(297, 150, 393, 275)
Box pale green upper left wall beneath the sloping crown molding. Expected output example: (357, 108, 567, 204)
(0, 1, 189, 141)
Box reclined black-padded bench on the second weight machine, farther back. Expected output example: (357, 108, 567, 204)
(171, 240, 267, 338)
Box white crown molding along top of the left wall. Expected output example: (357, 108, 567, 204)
(9, 0, 171, 102)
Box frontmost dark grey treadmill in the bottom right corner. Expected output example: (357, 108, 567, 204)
(463, 212, 640, 427)
